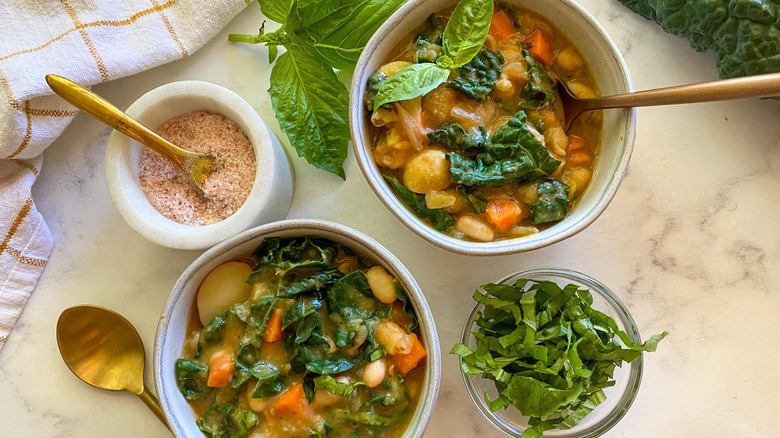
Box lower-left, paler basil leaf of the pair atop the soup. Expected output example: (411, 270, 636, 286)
(374, 62, 450, 109)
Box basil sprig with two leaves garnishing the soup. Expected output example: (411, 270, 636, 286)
(374, 0, 493, 109)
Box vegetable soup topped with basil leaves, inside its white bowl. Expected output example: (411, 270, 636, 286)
(364, 0, 601, 242)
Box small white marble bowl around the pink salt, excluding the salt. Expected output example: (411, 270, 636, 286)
(106, 81, 293, 249)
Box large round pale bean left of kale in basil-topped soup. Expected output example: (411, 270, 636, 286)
(401, 149, 452, 193)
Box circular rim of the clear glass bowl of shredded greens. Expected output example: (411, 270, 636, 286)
(458, 267, 644, 438)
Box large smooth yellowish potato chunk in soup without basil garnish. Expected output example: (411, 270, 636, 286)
(198, 262, 252, 326)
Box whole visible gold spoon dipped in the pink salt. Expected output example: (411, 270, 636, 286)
(46, 75, 214, 193)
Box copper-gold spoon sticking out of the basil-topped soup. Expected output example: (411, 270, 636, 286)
(558, 73, 780, 132)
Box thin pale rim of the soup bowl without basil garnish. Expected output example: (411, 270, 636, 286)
(153, 219, 441, 438)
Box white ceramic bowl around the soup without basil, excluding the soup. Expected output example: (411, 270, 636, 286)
(154, 219, 441, 438)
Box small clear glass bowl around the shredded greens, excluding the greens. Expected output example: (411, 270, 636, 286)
(460, 268, 643, 438)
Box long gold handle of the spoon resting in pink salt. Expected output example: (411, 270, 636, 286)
(46, 75, 190, 167)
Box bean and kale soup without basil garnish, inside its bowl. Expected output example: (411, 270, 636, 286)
(176, 237, 427, 438)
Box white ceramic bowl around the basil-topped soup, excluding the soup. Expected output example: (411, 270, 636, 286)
(349, 0, 636, 255)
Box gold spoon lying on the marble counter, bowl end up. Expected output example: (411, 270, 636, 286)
(57, 306, 170, 429)
